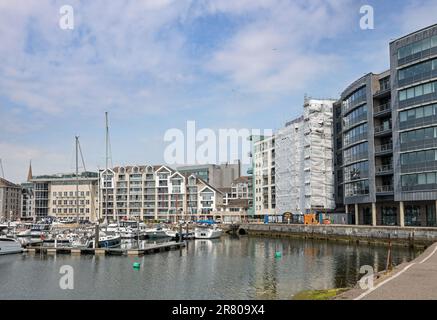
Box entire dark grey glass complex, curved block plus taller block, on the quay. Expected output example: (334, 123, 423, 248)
(334, 25, 437, 226)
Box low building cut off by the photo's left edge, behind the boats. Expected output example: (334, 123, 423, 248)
(0, 178, 21, 221)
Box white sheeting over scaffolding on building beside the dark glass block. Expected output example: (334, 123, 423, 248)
(275, 100, 335, 214)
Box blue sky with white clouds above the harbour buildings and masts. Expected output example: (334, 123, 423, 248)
(0, 0, 437, 183)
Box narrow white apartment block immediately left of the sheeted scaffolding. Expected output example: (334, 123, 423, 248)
(252, 136, 276, 216)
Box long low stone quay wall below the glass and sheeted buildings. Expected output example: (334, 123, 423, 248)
(238, 223, 437, 247)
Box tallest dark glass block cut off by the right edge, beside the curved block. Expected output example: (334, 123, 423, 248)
(390, 25, 437, 226)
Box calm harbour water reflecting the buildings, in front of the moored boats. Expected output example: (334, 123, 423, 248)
(0, 236, 419, 300)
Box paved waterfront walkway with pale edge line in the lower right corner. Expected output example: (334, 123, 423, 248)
(335, 243, 437, 300)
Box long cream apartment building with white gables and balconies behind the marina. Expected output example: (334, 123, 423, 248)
(100, 165, 223, 221)
